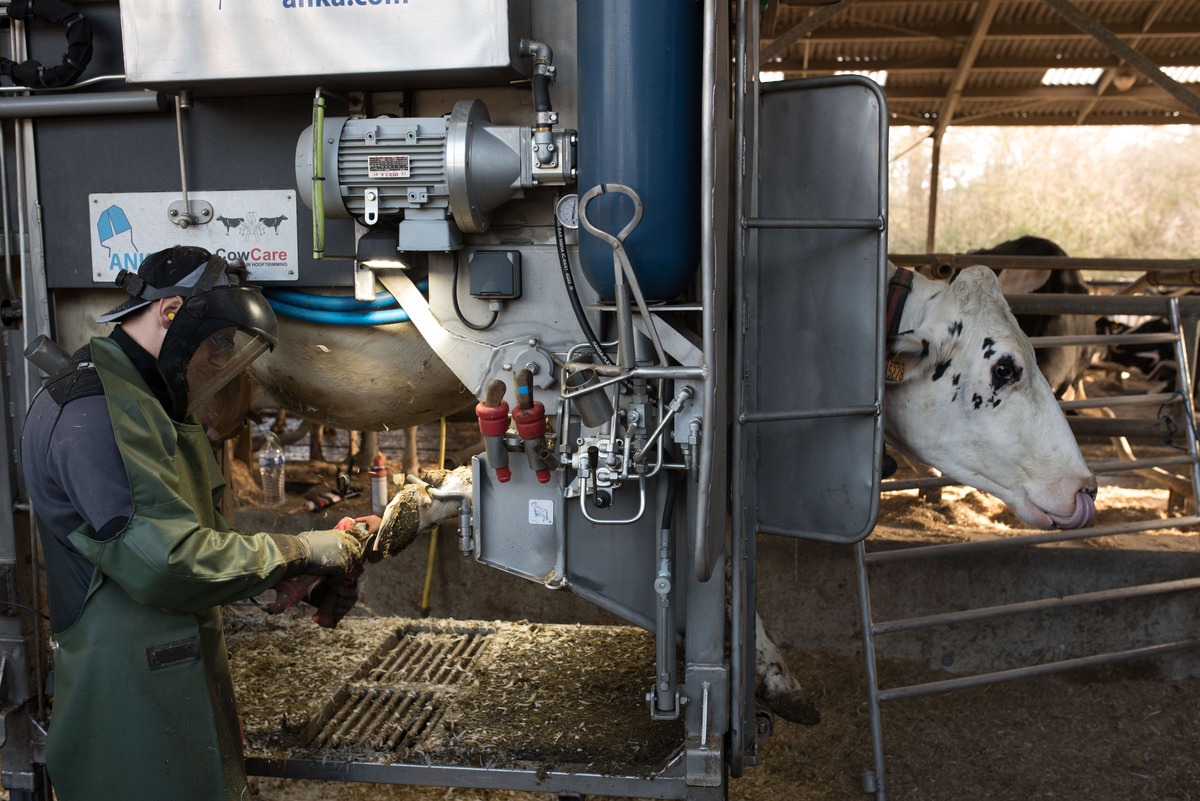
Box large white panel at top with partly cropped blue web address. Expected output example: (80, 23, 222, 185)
(121, 0, 530, 94)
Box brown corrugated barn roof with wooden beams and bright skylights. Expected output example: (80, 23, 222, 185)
(760, 0, 1200, 130)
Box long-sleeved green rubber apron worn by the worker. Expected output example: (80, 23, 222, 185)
(46, 338, 283, 801)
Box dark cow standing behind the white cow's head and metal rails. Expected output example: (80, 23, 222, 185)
(968, 236, 1099, 398)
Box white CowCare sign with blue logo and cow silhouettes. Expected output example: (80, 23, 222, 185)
(88, 189, 300, 285)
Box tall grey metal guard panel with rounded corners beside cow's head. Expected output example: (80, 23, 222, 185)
(745, 76, 888, 543)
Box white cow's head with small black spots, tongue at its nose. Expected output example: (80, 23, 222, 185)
(884, 266, 1096, 528)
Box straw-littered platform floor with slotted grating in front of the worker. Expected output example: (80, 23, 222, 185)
(226, 614, 684, 783)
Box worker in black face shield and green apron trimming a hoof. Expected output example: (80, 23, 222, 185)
(22, 246, 362, 801)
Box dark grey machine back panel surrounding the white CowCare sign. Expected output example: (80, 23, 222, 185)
(36, 94, 354, 289)
